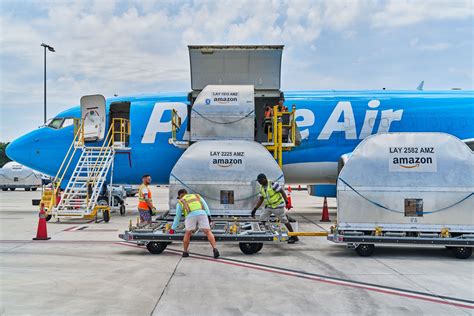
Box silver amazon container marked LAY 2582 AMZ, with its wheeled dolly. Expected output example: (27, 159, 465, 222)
(328, 133, 474, 258)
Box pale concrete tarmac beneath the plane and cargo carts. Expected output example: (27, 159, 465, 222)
(0, 187, 474, 316)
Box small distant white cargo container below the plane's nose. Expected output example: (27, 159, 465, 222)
(0, 161, 41, 191)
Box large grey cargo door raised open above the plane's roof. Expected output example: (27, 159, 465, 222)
(188, 45, 283, 91)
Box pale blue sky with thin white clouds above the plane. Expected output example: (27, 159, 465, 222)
(0, 0, 474, 141)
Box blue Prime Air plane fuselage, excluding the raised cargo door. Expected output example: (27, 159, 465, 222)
(6, 90, 474, 198)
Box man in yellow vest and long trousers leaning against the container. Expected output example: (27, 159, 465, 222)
(252, 173, 298, 244)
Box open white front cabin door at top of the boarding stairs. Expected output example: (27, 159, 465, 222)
(81, 94, 106, 142)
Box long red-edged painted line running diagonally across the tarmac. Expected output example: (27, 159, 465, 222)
(116, 242, 474, 309)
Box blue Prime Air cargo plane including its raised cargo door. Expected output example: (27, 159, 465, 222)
(6, 45, 474, 197)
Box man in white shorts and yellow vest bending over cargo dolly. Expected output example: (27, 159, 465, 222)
(170, 189, 219, 258)
